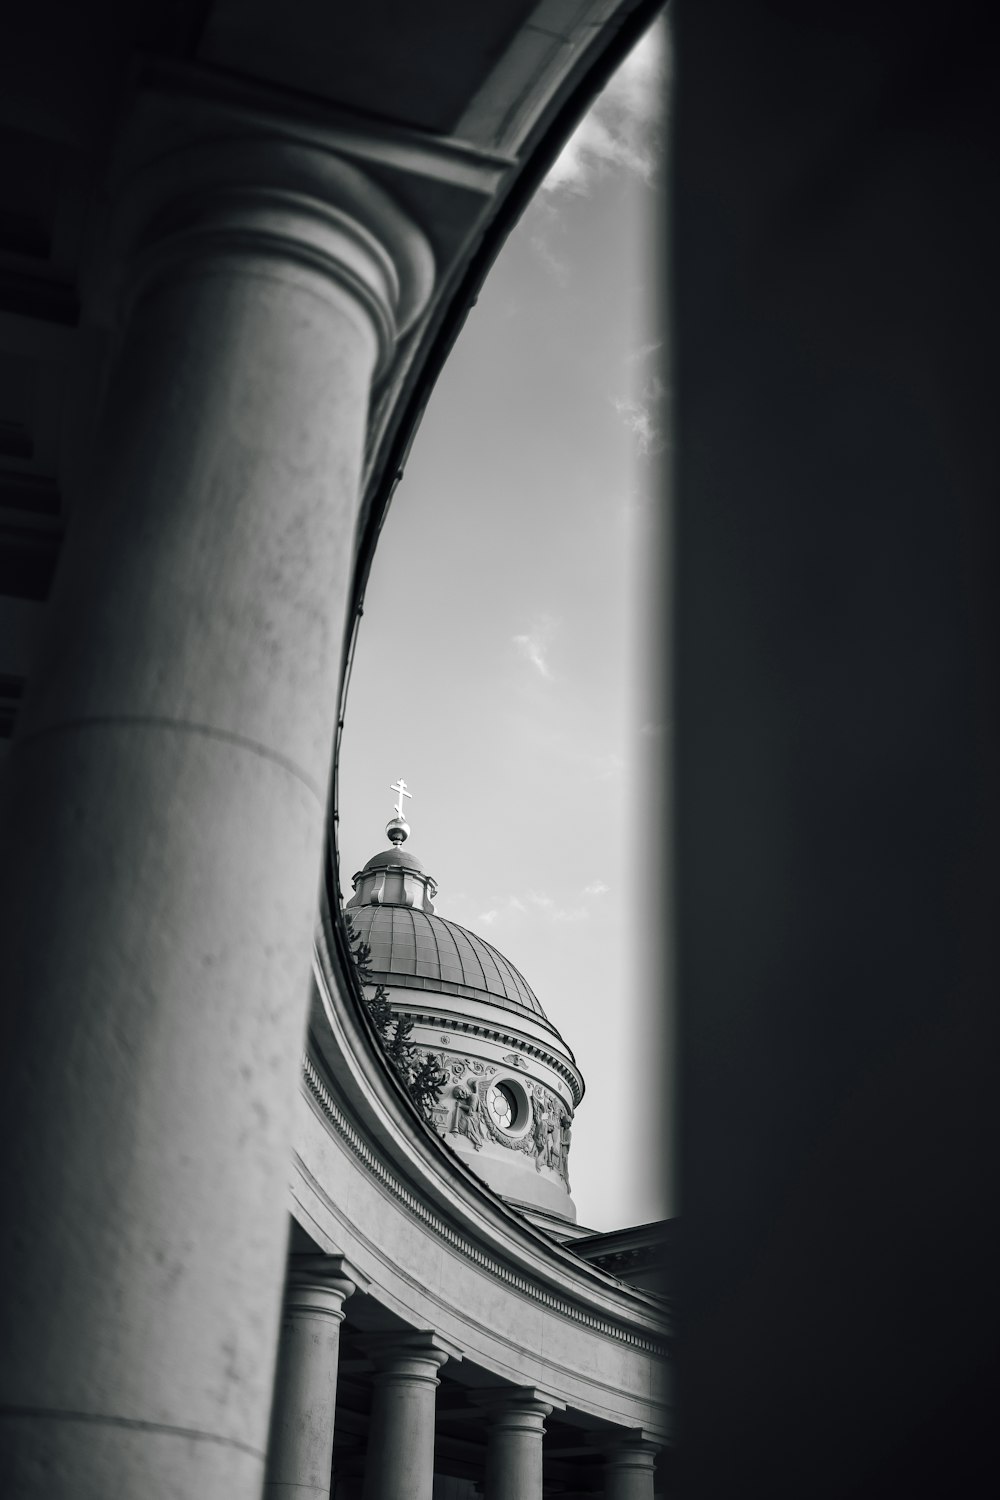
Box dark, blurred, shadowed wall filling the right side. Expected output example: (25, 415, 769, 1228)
(670, 0, 1000, 1500)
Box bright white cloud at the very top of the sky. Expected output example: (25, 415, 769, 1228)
(541, 23, 667, 195)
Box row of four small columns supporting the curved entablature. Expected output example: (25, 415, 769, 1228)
(264, 1256, 657, 1500)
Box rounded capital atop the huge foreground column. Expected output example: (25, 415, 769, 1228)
(102, 93, 435, 374)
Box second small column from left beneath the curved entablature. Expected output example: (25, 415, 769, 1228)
(364, 1334, 457, 1500)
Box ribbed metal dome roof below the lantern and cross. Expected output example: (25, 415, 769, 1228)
(348, 906, 558, 1035)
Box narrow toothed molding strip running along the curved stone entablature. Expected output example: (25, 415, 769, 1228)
(303, 1055, 669, 1359)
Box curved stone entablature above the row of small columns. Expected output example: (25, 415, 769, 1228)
(291, 906, 670, 1440)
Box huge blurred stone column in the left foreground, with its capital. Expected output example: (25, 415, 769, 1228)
(0, 107, 430, 1500)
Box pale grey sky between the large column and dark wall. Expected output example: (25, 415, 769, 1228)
(339, 24, 673, 1230)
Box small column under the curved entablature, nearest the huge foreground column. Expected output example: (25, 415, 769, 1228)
(264, 1256, 367, 1500)
